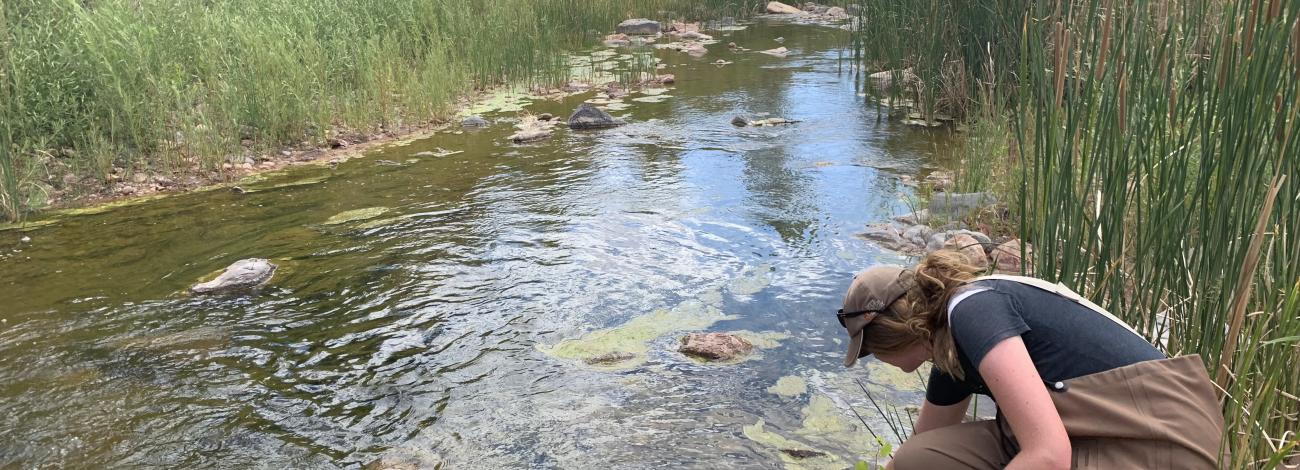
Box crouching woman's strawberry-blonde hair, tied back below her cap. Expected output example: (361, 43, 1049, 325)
(863, 249, 979, 379)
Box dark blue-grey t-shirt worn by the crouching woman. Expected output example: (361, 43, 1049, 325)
(926, 279, 1165, 406)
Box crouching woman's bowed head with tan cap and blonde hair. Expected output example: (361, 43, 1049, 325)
(841, 251, 979, 377)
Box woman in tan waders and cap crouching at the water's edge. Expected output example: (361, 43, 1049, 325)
(837, 252, 1223, 470)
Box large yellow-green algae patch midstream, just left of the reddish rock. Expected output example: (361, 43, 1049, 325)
(537, 300, 732, 369)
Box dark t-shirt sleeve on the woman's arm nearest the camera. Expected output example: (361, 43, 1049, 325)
(949, 290, 1030, 370)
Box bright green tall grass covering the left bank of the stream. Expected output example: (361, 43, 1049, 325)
(0, 0, 757, 218)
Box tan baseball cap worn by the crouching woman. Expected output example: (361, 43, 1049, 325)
(836, 265, 914, 367)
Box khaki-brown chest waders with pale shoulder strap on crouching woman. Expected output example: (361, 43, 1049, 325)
(893, 275, 1223, 470)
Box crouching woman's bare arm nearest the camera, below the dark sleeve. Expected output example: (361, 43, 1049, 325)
(979, 336, 1071, 470)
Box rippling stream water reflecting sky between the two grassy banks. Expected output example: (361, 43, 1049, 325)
(0, 23, 961, 469)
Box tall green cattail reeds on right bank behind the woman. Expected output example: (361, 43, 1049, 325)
(861, 0, 1300, 469)
